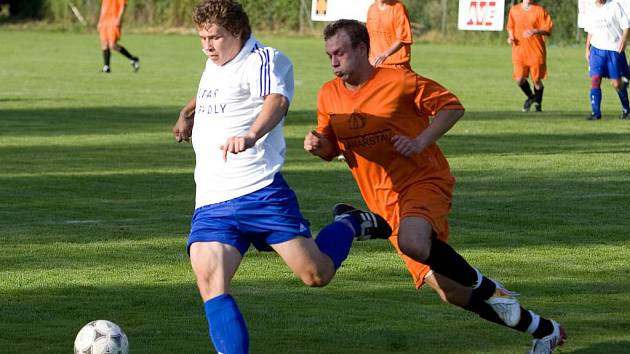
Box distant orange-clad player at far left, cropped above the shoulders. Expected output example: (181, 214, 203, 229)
(97, 0, 140, 73)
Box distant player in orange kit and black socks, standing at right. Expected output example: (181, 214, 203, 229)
(507, 0, 553, 112)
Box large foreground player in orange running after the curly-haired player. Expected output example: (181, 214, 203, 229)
(304, 20, 566, 353)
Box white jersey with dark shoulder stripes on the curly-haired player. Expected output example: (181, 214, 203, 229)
(192, 36, 294, 208)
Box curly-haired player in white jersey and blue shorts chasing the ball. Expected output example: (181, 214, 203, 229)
(173, 0, 391, 354)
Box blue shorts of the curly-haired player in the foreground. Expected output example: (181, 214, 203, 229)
(186, 173, 311, 255)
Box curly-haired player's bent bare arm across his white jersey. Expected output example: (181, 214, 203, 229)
(220, 93, 289, 160)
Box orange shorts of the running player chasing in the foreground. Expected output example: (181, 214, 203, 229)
(387, 183, 453, 288)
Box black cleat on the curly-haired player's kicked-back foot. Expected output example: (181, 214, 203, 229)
(333, 203, 392, 241)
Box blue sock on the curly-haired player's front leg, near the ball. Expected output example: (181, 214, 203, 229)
(204, 294, 249, 354)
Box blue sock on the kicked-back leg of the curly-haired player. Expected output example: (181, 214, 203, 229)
(315, 221, 354, 269)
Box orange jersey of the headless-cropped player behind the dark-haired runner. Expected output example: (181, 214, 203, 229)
(366, 1, 412, 65)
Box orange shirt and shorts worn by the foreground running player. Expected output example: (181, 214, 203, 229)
(317, 68, 463, 286)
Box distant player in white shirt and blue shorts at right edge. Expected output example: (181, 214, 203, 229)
(584, 0, 630, 120)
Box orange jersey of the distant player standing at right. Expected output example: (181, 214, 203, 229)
(507, 4, 553, 65)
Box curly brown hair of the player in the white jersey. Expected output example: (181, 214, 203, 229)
(193, 0, 252, 42)
